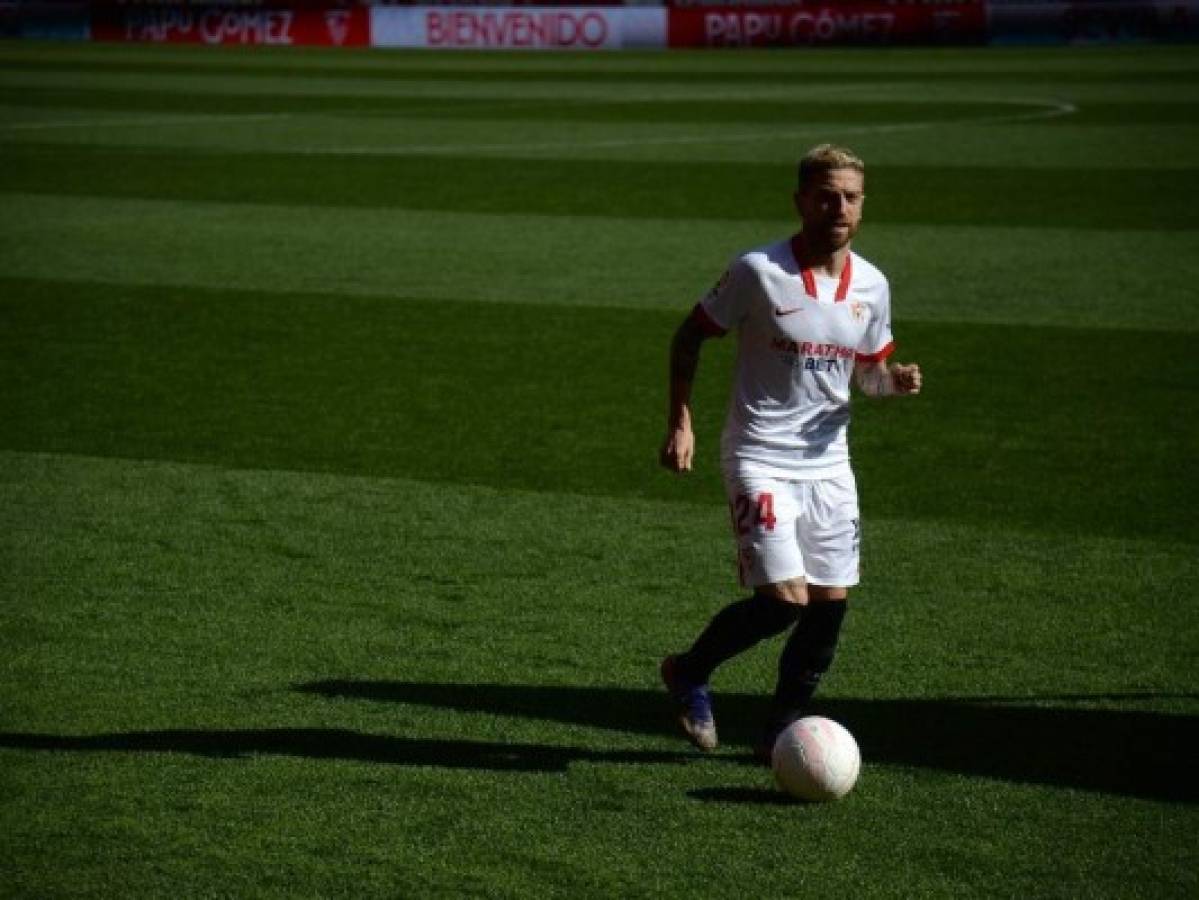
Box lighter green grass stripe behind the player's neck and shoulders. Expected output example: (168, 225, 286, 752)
(0, 194, 1199, 333)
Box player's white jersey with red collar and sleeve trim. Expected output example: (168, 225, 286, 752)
(693, 235, 893, 479)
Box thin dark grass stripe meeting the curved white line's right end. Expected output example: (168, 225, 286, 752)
(0, 85, 1199, 127)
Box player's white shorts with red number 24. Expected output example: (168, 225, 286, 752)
(724, 472, 861, 587)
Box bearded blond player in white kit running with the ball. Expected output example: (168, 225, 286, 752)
(661, 144, 921, 761)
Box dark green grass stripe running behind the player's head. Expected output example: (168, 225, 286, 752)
(0, 144, 1199, 230)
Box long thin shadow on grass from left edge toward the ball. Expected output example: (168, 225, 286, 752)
(0, 729, 694, 772)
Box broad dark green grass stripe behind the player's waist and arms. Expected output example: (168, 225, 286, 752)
(0, 279, 1199, 540)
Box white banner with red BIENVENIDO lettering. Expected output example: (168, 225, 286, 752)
(370, 6, 667, 50)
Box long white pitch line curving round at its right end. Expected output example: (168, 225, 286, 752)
(297, 97, 1078, 156)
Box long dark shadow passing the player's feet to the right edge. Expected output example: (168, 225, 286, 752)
(296, 681, 1199, 803)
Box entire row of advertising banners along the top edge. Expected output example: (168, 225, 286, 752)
(37, 0, 1199, 50)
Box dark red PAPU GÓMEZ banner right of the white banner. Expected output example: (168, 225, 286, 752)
(669, 0, 987, 47)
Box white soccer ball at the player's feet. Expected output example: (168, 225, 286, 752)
(771, 715, 862, 801)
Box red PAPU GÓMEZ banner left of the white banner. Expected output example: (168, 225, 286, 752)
(91, 4, 370, 47)
